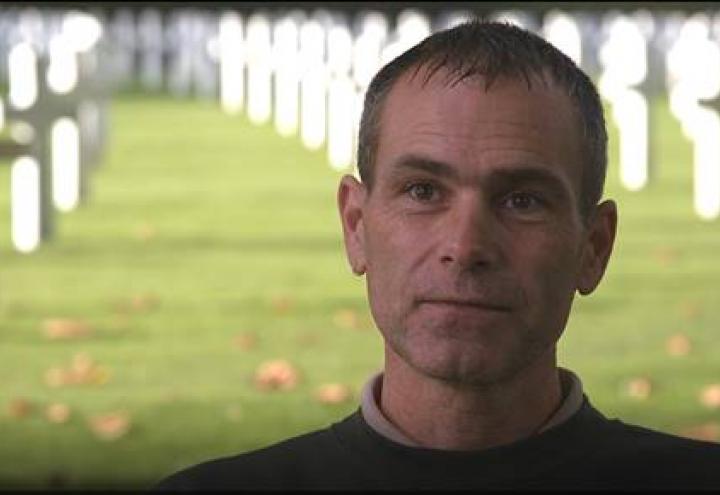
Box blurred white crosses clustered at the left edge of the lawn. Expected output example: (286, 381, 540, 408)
(0, 12, 112, 253)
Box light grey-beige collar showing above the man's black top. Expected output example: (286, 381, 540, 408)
(360, 368, 583, 447)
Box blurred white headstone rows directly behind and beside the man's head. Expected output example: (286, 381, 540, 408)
(59, 5, 720, 219)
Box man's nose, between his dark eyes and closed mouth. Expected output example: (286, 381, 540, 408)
(440, 198, 501, 269)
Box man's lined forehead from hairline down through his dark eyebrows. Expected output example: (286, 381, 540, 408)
(376, 64, 583, 202)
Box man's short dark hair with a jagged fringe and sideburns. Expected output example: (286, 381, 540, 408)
(357, 19, 607, 219)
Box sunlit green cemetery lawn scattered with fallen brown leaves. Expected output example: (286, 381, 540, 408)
(0, 95, 720, 488)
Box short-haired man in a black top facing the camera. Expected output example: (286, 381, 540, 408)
(160, 21, 720, 489)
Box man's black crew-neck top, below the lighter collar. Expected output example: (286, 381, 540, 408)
(156, 397, 720, 490)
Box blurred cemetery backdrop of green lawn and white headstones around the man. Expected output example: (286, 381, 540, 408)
(0, 2, 720, 489)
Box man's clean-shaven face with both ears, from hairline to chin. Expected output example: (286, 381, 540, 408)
(339, 71, 615, 384)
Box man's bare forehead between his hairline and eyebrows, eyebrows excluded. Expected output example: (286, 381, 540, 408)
(379, 71, 580, 147)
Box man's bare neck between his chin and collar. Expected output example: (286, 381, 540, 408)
(379, 350, 562, 450)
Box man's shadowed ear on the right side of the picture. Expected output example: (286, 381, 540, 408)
(577, 200, 617, 296)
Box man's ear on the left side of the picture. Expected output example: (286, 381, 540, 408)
(338, 175, 367, 275)
